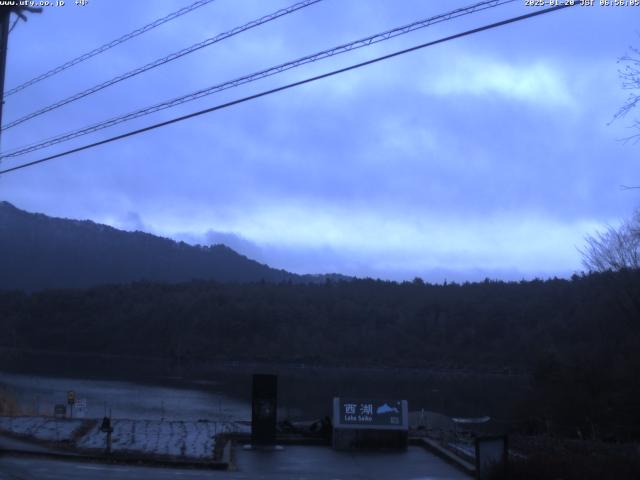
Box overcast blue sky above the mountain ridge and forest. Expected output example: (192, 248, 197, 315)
(0, 0, 640, 283)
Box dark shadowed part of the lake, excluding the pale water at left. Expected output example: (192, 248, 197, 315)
(0, 349, 530, 418)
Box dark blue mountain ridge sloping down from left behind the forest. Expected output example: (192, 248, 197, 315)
(0, 201, 349, 291)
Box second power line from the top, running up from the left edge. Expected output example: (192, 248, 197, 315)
(2, 0, 322, 130)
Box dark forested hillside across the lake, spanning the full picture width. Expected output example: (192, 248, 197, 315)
(0, 271, 640, 433)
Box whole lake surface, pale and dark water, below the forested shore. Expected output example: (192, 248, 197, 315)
(0, 349, 527, 420)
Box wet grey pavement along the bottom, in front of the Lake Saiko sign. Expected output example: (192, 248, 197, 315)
(0, 447, 469, 480)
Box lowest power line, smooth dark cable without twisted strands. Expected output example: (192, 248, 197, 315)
(0, 3, 579, 175)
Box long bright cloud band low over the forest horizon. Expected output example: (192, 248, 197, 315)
(139, 204, 600, 279)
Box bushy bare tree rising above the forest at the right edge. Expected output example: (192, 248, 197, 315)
(580, 209, 640, 272)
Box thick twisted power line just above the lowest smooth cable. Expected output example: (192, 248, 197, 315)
(0, 0, 516, 160)
